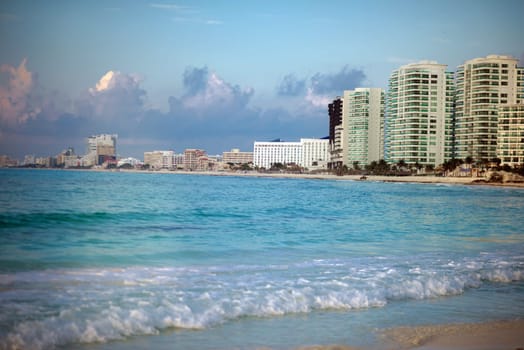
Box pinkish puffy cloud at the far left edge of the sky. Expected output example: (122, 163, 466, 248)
(0, 59, 41, 126)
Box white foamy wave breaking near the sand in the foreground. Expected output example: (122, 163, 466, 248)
(0, 255, 524, 349)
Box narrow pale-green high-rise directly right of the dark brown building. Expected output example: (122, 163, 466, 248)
(341, 88, 384, 167)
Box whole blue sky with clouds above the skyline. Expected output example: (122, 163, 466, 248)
(0, 0, 524, 159)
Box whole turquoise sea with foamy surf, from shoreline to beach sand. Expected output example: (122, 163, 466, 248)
(0, 169, 524, 350)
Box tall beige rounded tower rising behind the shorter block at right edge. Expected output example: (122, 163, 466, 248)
(455, 55, 524, 160)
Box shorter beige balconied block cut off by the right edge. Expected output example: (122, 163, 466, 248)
(497, 101, 524, 166)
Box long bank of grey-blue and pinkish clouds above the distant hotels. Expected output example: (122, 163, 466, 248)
(0, 60, 366, 158)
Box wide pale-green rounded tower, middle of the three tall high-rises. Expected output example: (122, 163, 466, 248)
(386, 61, 454, 166)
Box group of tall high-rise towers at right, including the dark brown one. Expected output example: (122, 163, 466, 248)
(328, 55, 524, 168)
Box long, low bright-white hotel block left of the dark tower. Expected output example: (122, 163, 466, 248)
(253, 139, 329, 169)
